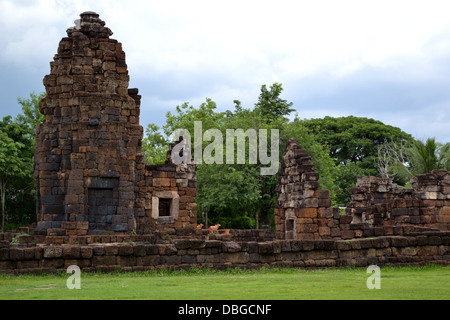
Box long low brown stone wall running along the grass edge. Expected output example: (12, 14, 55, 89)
(0, 232, 450, 274)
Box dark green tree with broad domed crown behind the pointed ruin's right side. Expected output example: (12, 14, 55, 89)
(302, 116, 413, 206)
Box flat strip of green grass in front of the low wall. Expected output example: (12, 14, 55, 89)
(0, 266, 450, 300)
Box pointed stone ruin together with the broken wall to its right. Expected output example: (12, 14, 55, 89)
(275, 139, 450, 240)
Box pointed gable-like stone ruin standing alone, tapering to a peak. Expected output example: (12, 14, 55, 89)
(275, 139, 340, 240)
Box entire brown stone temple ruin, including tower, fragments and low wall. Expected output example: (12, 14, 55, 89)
(0, 12, 450, 274)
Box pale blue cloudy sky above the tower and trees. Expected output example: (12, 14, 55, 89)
(0, 0, 450, 142)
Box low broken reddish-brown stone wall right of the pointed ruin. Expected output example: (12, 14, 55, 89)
(346, 170, 450, 235)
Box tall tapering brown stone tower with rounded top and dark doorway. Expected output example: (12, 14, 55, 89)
(35, 12, 145, 235)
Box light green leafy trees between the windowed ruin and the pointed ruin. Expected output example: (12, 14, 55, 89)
(155, 83, 334, 228)
